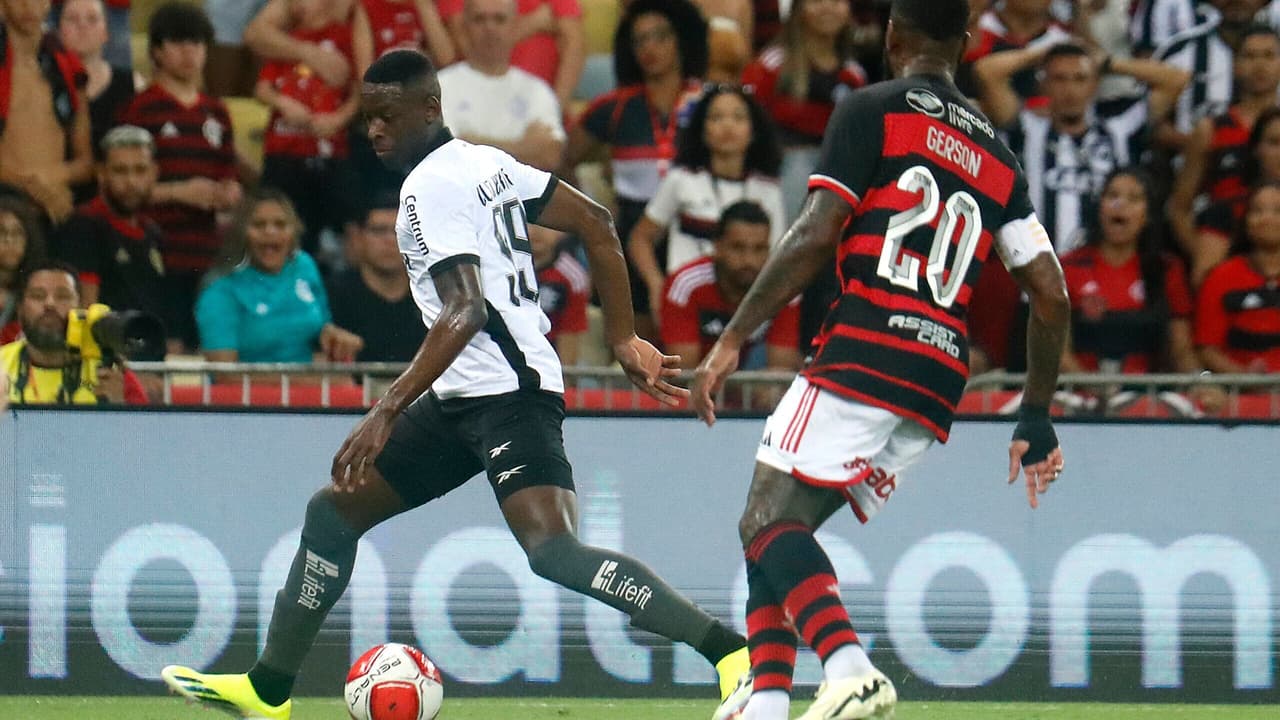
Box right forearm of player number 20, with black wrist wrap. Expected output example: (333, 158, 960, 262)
(1009, 252, 1071, 509)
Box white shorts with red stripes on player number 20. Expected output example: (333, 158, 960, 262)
(755, 375, 937, 523)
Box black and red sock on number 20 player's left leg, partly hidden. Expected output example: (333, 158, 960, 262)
(746, 560, 796, 694)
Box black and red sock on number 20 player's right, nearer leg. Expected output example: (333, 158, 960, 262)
(746, 521, 858, 664)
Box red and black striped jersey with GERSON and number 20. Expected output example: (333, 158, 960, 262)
(804, 76, 1053, 441)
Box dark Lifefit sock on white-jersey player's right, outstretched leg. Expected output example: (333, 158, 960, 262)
(529, 533, 746, 662)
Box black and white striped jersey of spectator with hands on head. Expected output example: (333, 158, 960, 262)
(1005, 97, 1148, 249)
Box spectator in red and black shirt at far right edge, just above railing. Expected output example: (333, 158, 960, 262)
(1196, 182, 1280, 373)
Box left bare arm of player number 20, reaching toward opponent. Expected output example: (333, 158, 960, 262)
(691, 188, 854, 425)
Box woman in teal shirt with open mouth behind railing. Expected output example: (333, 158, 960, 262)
(196, 191, 364, 363)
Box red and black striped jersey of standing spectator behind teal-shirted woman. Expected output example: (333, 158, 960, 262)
(120, 85, 237, 273)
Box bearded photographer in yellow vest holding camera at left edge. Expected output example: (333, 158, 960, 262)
(0, 263, 151, 405)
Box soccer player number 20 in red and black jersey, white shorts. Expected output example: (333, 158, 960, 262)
(692, 0, 1070, 720)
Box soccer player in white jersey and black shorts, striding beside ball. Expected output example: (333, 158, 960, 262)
(161, 50, 749, 720)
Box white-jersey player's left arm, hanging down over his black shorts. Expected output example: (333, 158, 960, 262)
(330, 263, 489, 492)
